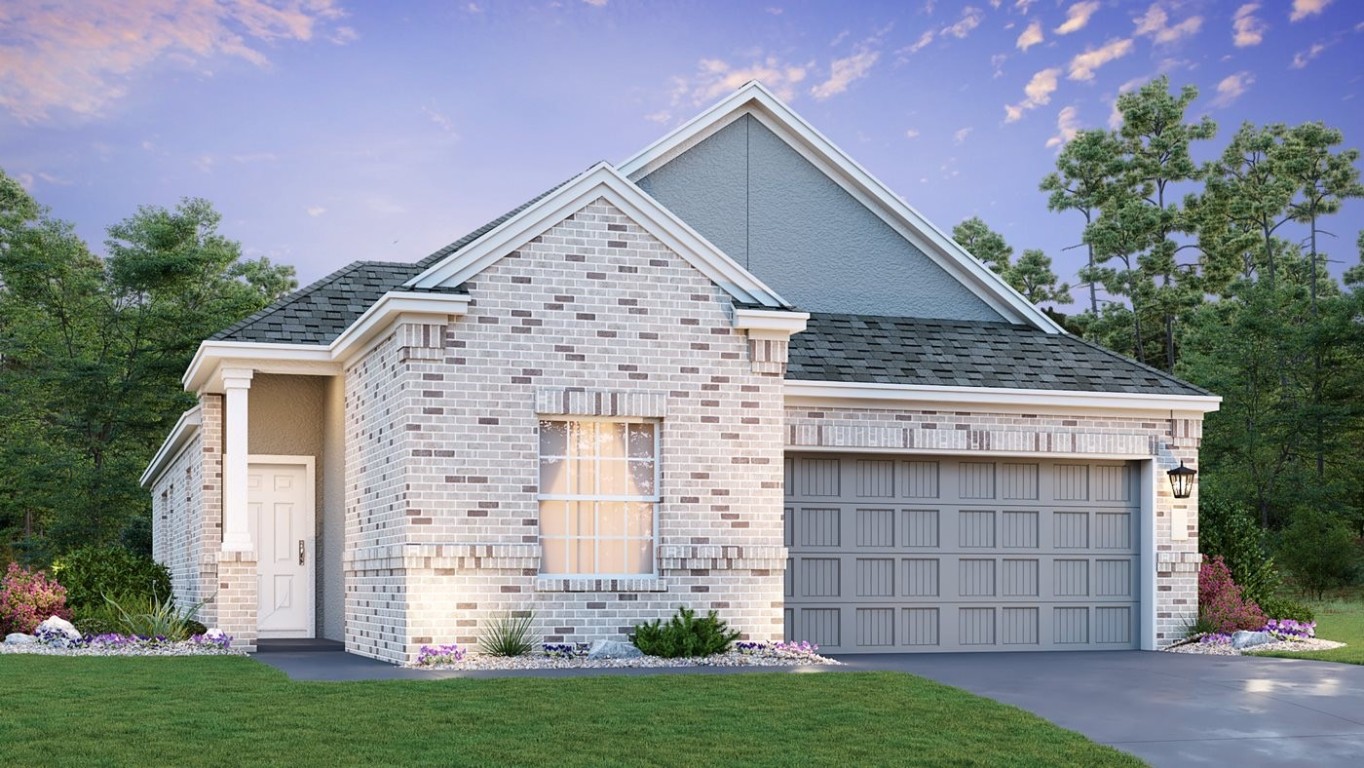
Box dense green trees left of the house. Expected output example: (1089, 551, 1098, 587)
(0, 186, 296, 559)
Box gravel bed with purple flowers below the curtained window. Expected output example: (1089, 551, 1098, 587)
(409, 641, 839, 670)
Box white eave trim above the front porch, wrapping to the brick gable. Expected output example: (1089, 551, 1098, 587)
(180, 291, 469, 393)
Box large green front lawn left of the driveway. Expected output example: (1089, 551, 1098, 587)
(0, 655, 1142, 768)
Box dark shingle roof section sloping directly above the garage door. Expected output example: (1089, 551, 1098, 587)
(786, 312, 1210, 396)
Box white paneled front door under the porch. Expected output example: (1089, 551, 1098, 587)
(247, 456, 315, 638)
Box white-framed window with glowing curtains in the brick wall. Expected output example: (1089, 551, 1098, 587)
(540, 420, 659, 576)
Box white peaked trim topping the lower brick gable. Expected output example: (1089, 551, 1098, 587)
(406, 162, 787, 307)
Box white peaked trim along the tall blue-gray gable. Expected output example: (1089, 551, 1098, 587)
(619, 82, 1065, 333)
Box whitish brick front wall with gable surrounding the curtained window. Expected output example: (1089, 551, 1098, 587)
(346, 201, 784, 660)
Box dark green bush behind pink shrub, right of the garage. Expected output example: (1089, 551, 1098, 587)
(1198, 494, 1289, 608)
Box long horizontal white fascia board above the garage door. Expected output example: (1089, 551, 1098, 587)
(786, 379, 1222, 419)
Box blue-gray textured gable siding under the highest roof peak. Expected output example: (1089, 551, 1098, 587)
(640, 116, 1003, 322)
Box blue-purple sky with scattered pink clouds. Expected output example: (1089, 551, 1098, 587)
(0, 0, 1364, 309)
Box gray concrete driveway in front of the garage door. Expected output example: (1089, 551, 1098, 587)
(840, 651, 1364, 767)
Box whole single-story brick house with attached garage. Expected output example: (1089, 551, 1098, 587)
(143, 83, 1218, 663)
